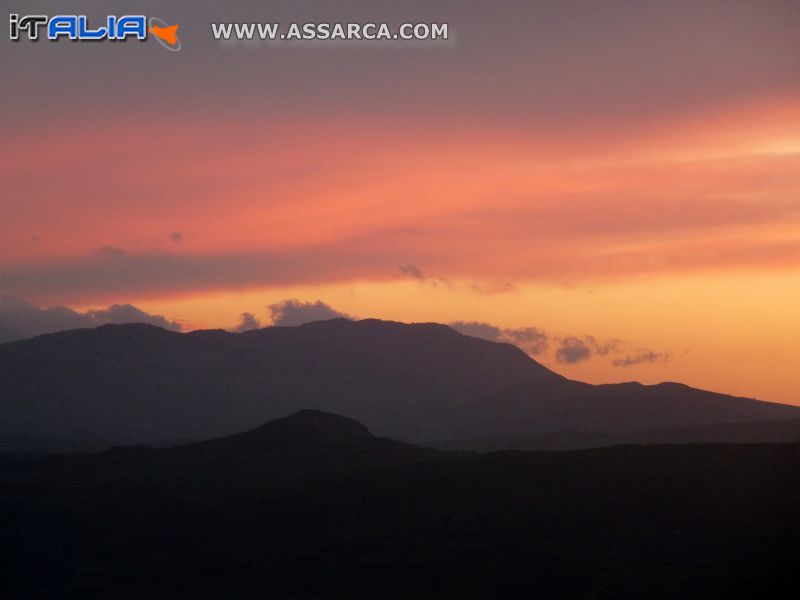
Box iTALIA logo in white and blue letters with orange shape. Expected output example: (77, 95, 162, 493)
(9, 13, 181, 52)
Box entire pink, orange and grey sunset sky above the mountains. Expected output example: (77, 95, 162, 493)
(0, 0, 800, 404)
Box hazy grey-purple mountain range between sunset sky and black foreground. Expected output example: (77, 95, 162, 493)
(0, 319, 800, 444)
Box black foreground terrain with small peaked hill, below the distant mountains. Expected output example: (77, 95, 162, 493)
(0, 411, 800, 598)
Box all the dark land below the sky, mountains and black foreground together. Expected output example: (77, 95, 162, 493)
(0, 319, 800, 598)
